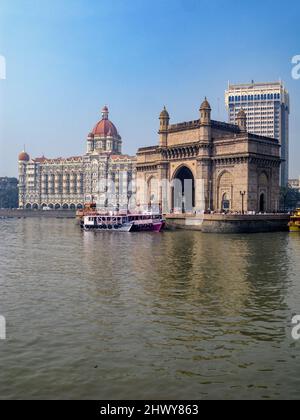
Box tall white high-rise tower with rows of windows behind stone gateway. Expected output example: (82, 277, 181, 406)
(225, 82, 290, 186)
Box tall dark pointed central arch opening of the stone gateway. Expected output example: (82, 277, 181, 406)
(171, 166, 195, 213)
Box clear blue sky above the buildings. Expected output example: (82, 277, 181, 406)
(0, 0, 300, 177)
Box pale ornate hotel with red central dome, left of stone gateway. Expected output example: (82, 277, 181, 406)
(19, 107, 136, 209)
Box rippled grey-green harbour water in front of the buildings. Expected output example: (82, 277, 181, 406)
(0, 219, 300, 399)
